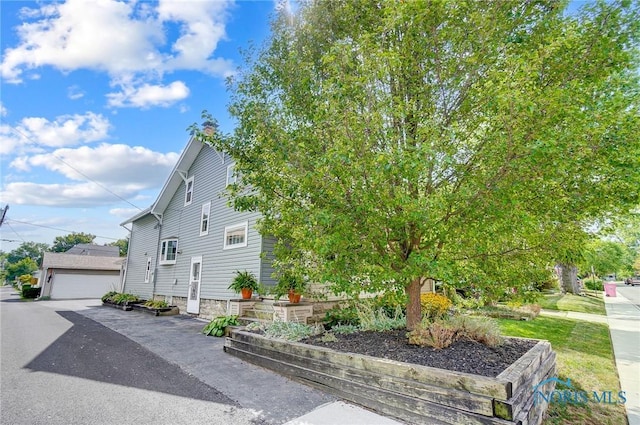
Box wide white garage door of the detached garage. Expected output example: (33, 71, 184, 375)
(51, 272, 120, 299)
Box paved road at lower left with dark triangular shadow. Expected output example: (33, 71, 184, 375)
(0, 287, 262, 425)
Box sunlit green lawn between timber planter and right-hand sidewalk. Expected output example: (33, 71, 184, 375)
(498, 316, 627, 425)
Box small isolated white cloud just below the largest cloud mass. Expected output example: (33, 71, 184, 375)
(107, 81, 189, 109)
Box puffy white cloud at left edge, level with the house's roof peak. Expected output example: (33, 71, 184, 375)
(0, 112, 110, 155)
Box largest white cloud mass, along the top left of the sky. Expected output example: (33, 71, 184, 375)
(0, 0, 233, 89)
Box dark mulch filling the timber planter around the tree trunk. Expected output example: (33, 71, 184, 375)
(301, 329, 536, 377)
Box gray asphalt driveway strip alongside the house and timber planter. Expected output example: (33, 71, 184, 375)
(39, 300, 402, 425)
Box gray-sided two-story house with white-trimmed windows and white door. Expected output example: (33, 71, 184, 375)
(121, 138, 275, 318)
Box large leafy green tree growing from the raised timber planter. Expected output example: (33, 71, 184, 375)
(199, 0, 640, 328)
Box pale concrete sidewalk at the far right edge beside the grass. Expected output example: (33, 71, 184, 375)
(604, 291, 640, 425)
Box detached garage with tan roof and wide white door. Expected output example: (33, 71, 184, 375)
(40, 252, 123, 300)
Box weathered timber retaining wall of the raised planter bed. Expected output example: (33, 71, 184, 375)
(224, 328, 556, 425)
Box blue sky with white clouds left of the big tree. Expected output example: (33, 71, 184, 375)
(0, 0, 278, 252)
